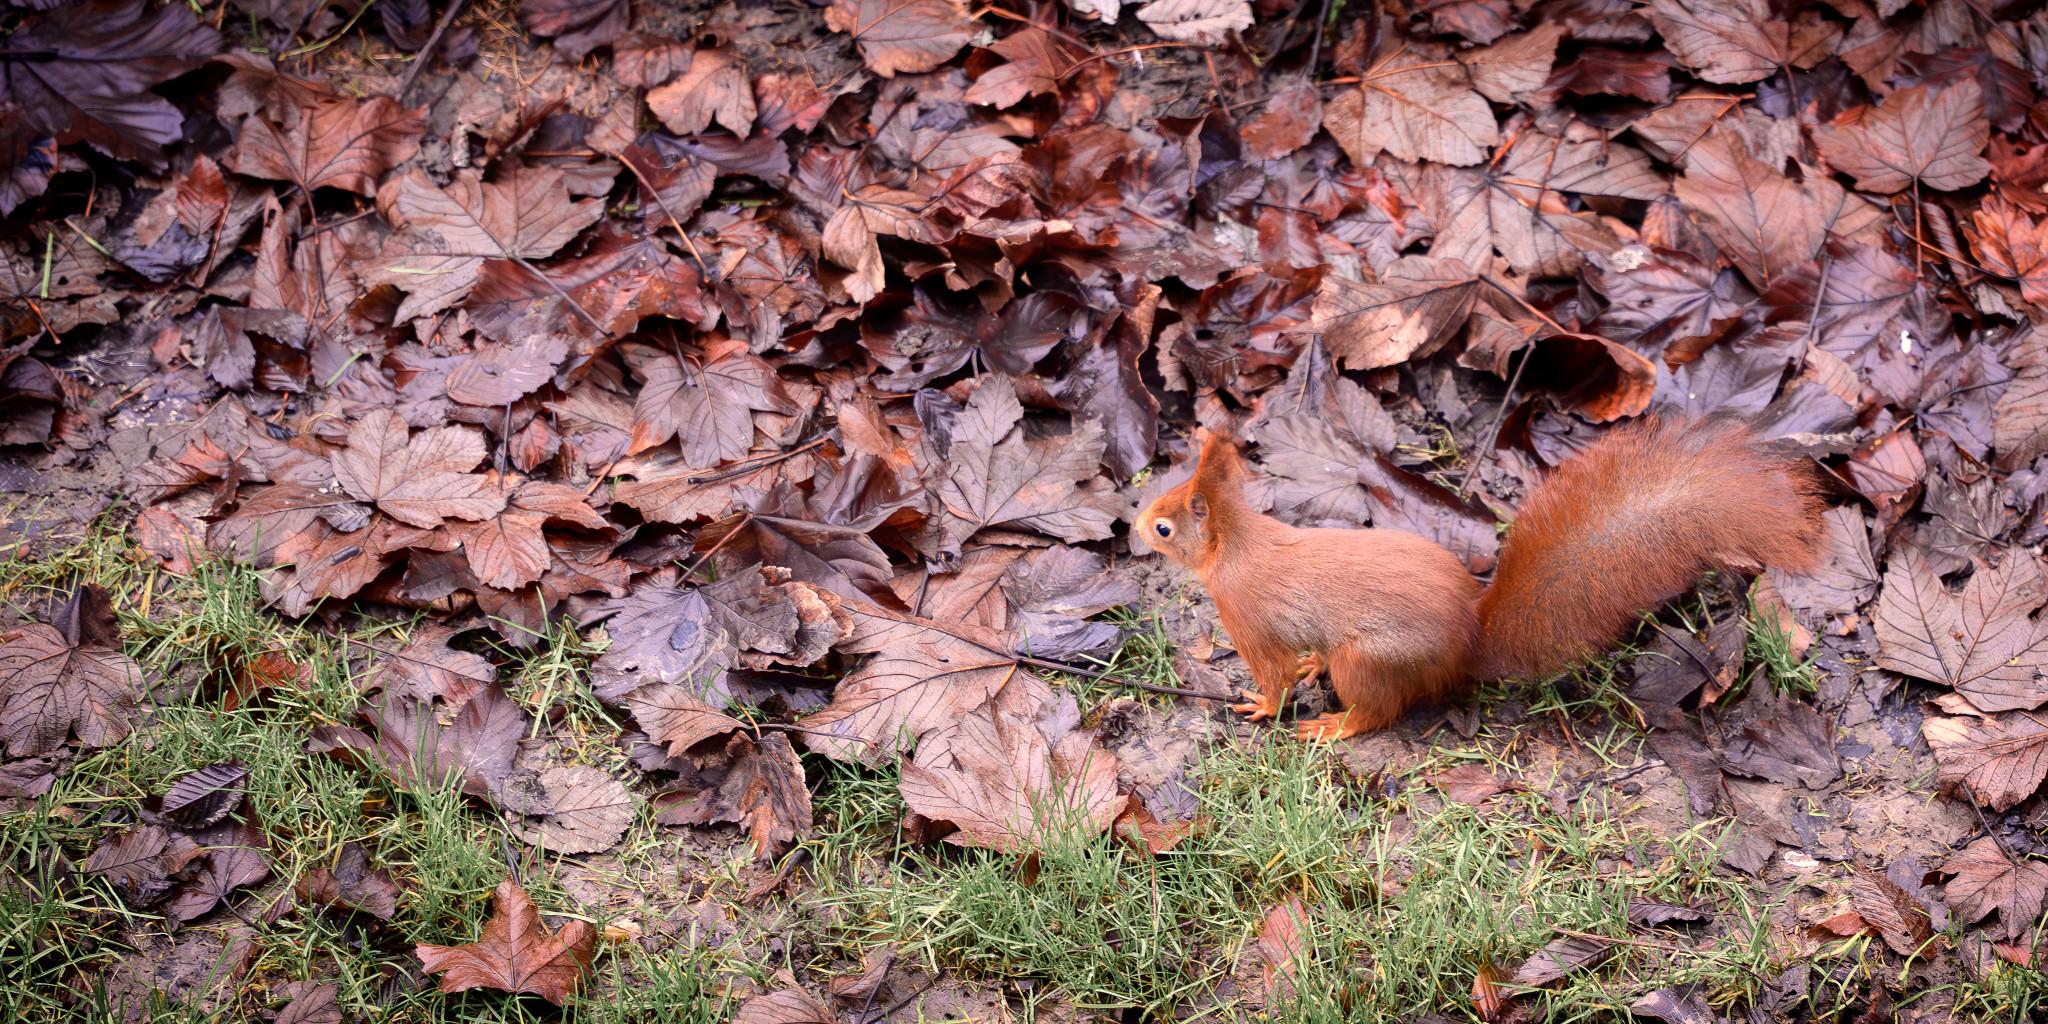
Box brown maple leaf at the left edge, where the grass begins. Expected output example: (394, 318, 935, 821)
(0, 584, 143, 758)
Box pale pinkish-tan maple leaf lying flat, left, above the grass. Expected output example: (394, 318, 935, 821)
(330, 410, 506, 528)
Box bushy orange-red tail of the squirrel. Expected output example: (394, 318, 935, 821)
(1477, 420, 1823, 678)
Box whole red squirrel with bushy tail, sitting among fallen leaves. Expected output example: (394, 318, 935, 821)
(1137, 420, 1823, 739)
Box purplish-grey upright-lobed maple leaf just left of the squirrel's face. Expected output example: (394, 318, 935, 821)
(932, 375, 1122, 545)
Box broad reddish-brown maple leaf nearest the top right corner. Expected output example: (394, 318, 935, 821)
(1812, 80, 1991, 193)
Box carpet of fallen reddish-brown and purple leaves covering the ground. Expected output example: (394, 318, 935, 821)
(0, 0, 2048, 1020)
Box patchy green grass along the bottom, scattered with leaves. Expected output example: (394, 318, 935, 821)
(12, 530, 2048, 1024)
